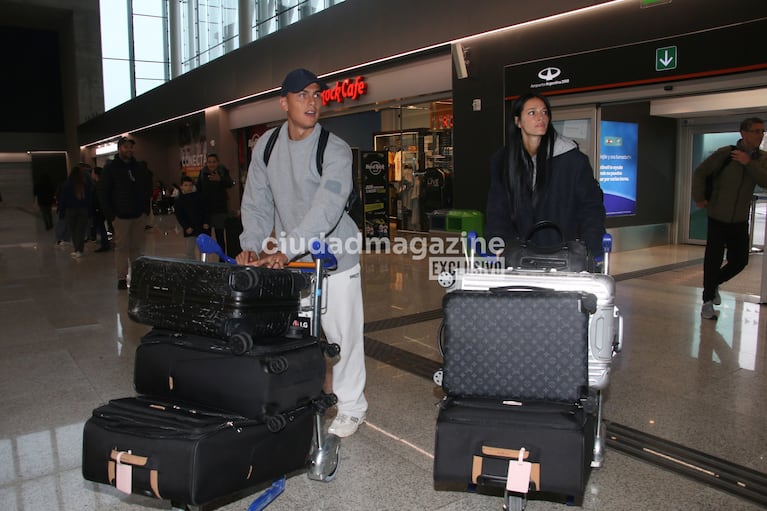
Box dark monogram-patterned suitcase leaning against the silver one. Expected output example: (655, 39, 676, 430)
(442, 288, 597, 403)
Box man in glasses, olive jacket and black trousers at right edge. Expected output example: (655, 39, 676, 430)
(692, 117, 767, 319)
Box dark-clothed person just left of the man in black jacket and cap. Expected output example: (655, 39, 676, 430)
(59, 166, 93, 259)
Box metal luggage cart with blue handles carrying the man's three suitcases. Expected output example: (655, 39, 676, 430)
(176, 234, 341, 511)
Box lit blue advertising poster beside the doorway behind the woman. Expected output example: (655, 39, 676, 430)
(599, 121, 639, 216)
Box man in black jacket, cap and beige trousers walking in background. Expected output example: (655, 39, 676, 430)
(99, 137, 152, 289)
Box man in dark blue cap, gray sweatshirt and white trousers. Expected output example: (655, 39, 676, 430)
(237, 69, 368, 437)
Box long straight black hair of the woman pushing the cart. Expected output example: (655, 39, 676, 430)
(504, 92, 557, 224)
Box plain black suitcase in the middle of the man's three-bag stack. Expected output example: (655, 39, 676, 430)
(133, 329, 338, 420)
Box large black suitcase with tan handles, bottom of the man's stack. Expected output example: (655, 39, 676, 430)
(82, 398, 314, 506)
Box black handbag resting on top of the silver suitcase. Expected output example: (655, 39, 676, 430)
(503, 220, 595, 272)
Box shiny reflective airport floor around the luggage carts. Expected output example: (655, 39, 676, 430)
(0, 203, 767, 511)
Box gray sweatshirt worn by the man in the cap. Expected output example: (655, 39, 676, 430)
(240, 122, 362, 271)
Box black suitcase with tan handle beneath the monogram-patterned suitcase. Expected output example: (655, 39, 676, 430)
(434, 398, 595, 496)
